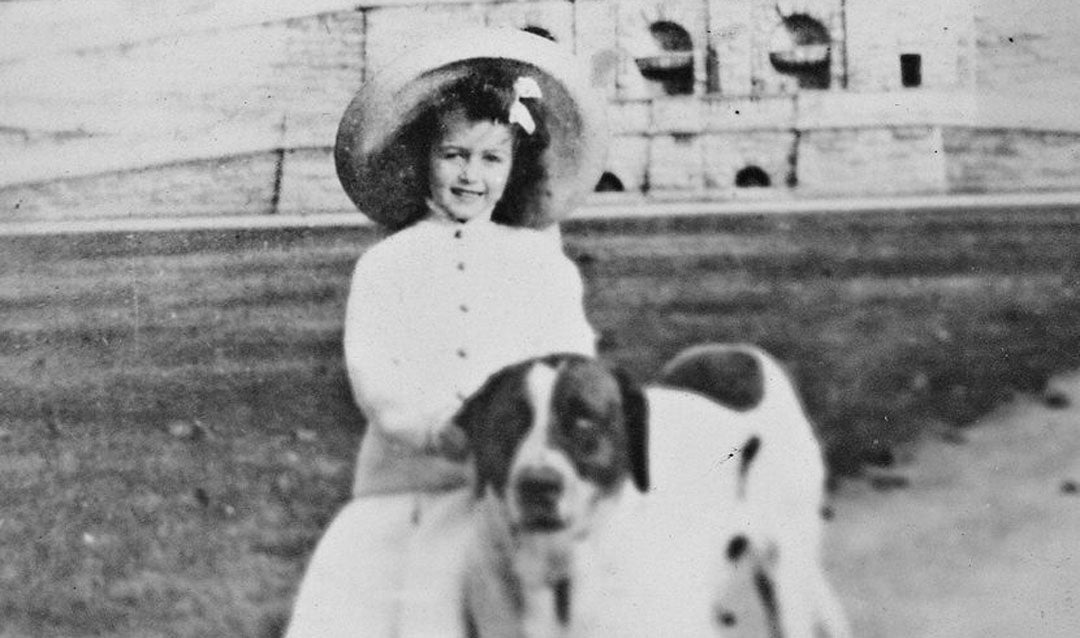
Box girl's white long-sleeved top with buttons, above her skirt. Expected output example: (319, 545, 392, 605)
(345, 212, 595, 496)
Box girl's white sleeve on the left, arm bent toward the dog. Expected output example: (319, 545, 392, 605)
(345, 249, 460, 451)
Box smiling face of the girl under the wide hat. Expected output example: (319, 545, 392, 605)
(428, 109, 514, 221)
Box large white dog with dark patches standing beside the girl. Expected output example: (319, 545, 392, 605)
(456, 345, 848, 638)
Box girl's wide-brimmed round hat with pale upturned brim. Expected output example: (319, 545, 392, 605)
(334, 28, 608, 228)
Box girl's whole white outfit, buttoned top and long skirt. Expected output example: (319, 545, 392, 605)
(287, 216, 595, 638)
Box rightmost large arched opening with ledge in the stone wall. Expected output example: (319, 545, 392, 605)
(769, 13, 832, 89)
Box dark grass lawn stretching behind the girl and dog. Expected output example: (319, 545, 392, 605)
(0, 208, 1080, 637)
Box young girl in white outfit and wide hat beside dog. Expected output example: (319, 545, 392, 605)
(288, 31, 603, 638)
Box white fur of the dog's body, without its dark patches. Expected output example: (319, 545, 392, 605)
(469, 349, 850, 638)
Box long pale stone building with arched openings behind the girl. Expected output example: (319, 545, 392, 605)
(0, 0, 1080, 221)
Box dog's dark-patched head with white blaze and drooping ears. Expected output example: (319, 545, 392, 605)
(455, 354, 648, 532)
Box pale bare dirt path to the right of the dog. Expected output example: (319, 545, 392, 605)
(826, 374, 1080, 638)
